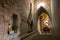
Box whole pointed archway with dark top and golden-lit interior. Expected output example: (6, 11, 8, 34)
(36, 6, 51, 33)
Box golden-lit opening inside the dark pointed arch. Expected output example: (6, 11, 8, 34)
(38, 13, 51, 33)
